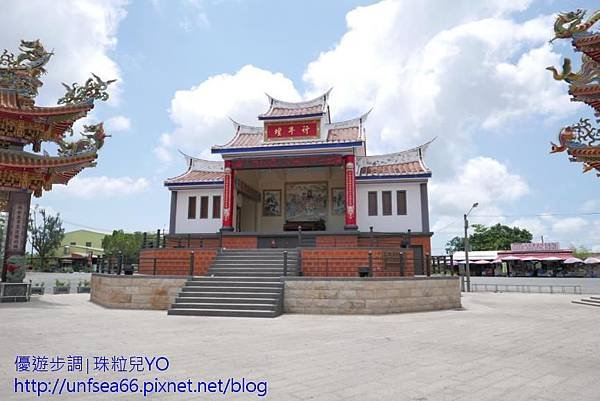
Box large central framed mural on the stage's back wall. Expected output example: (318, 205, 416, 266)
(285, 182, 328, 221)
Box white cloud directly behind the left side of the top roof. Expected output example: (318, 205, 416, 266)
(161, 65, 300, 161)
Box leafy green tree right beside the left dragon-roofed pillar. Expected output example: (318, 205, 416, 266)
(29, 206, 65, 269)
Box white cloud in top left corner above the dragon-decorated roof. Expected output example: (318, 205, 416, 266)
(0, 0, 126, 105)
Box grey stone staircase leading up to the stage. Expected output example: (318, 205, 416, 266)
(168, 248, 298, 317)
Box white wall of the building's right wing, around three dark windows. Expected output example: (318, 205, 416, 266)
(356, 180, 423, 232)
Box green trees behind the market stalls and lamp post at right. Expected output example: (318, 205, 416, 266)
(446, 223, 533, 253)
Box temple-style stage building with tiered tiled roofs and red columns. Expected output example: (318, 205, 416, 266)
(165, 91, 432, 270)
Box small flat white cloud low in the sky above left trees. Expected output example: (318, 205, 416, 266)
(56, 176, 150, 199)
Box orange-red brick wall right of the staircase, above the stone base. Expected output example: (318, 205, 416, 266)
(302, 248, 414, 277)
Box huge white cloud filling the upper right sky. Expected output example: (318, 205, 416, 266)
(304, 0, 578, 168)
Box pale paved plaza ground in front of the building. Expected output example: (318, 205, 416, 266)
(0, 293, 600, 401)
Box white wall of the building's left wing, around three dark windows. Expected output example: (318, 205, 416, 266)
(175, 187, 223, 234)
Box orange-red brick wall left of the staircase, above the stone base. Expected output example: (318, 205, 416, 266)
(138, 248, 217, 276)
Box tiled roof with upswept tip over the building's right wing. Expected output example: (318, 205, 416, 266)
(356, 141, 433, 177)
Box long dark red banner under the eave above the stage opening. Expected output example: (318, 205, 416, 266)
(231, 155, 344, 170)
